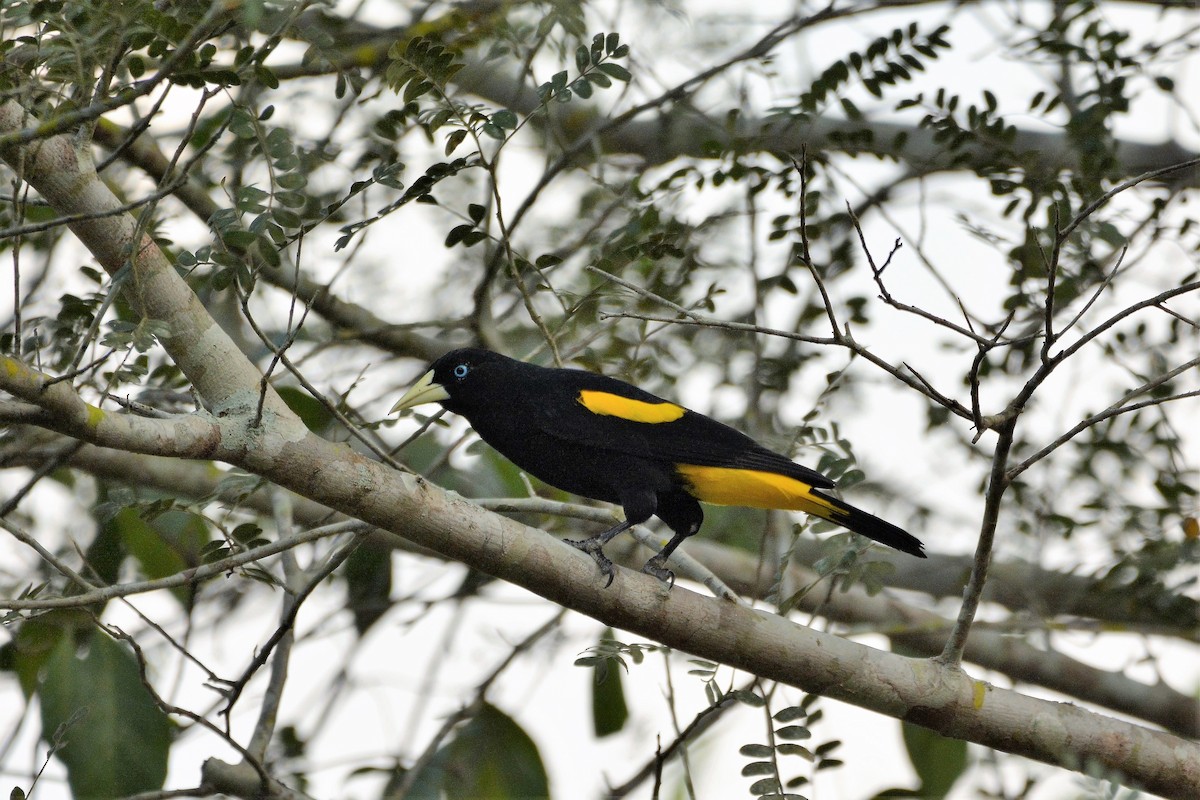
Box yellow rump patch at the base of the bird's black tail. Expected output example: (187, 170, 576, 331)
(676, 464, 845, 522)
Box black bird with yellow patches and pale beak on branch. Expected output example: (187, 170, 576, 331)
(390, 348, 925, 588)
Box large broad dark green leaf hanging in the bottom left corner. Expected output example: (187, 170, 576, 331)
(38, 632, 170, 800)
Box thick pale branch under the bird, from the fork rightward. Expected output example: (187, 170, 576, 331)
(244, 437, 1200, 798)
